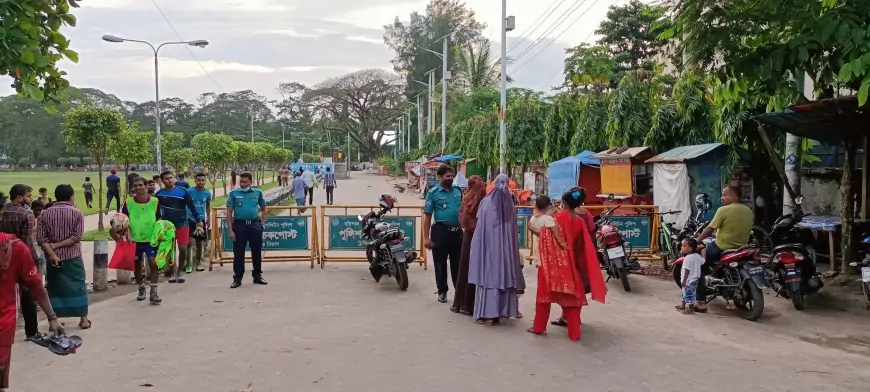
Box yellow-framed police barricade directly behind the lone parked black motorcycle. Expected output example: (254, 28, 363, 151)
(318, 205, 429, 270)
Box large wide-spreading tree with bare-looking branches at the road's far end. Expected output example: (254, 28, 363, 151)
(305, 69, 403, 159)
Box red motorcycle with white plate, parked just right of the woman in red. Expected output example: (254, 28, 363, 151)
(595, 196, 640, 291)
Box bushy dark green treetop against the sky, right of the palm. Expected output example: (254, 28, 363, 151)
(595, 0, 672, 87)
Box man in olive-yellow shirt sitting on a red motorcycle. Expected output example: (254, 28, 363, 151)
(695, 185, 755, 313)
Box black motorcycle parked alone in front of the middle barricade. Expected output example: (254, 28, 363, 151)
(358, 194, 417, 290)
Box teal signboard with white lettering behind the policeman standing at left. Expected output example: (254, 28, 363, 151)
(221, 216, 309, 252)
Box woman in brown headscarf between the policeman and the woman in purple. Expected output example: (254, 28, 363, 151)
(450, 176, 486, 315)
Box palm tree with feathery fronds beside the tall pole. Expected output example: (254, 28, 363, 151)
(456, 38, 513, 89)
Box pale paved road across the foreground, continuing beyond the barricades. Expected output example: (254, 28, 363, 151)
(12, 178, 870, 392)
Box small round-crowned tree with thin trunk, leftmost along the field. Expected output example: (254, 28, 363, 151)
(61, 106, 127, 230)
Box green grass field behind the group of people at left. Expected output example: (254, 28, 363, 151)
(0, 171, 272, 215)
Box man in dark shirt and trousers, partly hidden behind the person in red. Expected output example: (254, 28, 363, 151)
(0, 184, 42, 341)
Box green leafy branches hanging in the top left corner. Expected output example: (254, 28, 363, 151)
(0, 0, 79, 108)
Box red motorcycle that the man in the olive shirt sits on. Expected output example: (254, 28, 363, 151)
(674, 246, 767, 321)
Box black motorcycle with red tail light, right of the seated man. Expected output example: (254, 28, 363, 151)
(767, 196, 825, 310)
